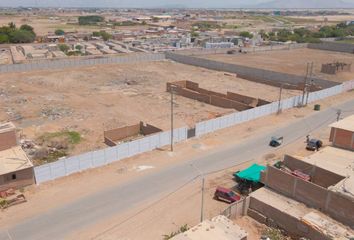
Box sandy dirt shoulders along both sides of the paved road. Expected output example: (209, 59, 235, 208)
(0, 92, 354, 240)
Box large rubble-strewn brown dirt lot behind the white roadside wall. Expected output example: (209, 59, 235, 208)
(0, 61, 300, 154)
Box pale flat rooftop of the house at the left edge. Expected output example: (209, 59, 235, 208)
(0, 146, 33, 175)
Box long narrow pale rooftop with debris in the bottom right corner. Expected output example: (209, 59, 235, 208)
(251, 188, 354, 239)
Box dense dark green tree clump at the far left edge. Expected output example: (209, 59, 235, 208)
(0, 22, 36, 43)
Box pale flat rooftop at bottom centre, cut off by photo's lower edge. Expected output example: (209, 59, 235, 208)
(172, 216, 247, 240)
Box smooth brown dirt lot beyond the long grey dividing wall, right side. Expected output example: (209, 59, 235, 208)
(203, 48, 354, 82)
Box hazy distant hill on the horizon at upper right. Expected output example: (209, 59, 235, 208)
(254, 0, 354, 8)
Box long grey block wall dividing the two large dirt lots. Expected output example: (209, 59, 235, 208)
(166, 52, 339, 90)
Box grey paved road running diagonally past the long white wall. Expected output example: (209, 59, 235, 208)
(0, 100, 354, 240)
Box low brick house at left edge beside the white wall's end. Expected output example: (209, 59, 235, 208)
(0, 123, 34, 191)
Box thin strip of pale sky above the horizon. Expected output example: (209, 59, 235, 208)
(0, 0, 354, 8)
